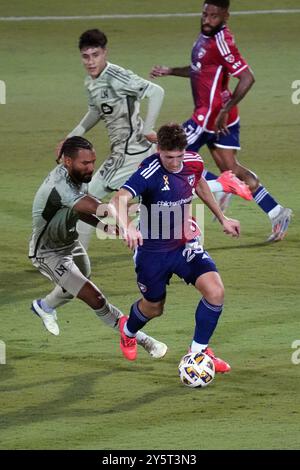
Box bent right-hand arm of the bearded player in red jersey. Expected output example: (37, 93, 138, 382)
(215, 68, 255, 134)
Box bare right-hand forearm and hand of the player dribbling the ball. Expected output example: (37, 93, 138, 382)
(195, 177, 240, 237)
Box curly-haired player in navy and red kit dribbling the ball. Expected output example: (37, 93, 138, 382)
(111, 123, 240, 372)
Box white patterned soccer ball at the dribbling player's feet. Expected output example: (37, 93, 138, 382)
(178, 352, 215, 388)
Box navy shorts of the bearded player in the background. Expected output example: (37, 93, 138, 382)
(182, 119, 241, 152)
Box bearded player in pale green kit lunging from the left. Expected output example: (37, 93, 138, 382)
(29, 137, 167, 358)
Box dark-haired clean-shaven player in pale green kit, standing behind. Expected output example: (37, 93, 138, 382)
(57, 29, 164, 248)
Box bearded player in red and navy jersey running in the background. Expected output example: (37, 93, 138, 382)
(151, 0, 292, 241)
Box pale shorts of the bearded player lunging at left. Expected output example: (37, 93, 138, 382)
(32, 241, 91, 297)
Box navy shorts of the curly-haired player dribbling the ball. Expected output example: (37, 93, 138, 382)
(134, 245, 218, 302)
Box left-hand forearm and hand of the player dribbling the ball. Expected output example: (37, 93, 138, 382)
(108, 188, 143, 250)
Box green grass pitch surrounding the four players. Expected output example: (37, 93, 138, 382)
(0, 0, 300, 450)
